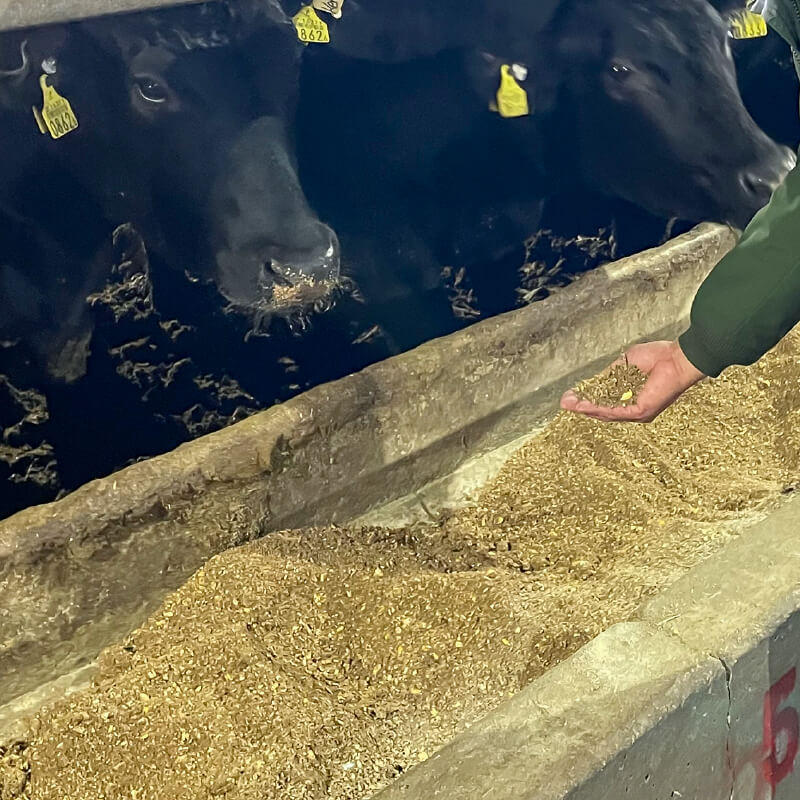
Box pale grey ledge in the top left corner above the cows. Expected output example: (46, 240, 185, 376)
(0, 0, 202, 31)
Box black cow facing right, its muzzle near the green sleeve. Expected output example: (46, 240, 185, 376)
(299, 0, 793, 346)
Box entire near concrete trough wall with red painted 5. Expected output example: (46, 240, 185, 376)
(376, 500, 800, 800)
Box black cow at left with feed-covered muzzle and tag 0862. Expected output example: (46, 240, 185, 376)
(0, 4, 339, 378)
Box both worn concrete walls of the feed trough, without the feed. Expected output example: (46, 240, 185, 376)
(9, 220, 800, 800)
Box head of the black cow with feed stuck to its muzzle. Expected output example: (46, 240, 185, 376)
(85, 4, 339, 319)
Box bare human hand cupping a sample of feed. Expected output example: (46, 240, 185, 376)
(561, 341, 706, 422)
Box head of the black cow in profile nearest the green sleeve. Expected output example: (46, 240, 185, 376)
(551, 0, 794, 226)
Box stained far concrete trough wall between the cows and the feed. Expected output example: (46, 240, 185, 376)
(0, 225, 735, 716)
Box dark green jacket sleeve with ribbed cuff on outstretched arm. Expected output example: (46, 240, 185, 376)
(679, 159, 800, 377)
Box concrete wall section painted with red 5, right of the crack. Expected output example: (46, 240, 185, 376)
(641, 500, 800, 800)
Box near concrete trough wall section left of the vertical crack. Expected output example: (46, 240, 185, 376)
(376, 623, 728, 800)
